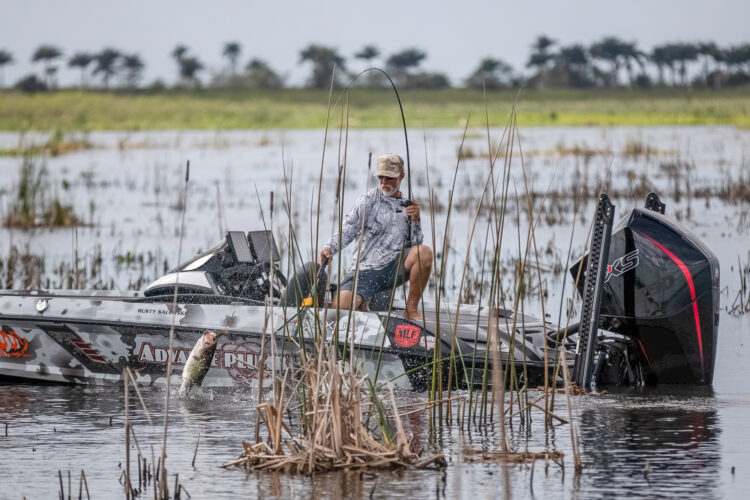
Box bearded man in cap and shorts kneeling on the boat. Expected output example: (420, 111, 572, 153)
(319, 154, 432, 320)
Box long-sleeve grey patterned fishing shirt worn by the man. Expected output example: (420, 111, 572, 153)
(326, 187, 422, 271)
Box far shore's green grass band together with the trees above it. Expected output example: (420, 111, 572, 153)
(0, 35, 750, 131)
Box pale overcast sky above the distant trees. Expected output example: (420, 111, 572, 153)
(0, 0, 750, 85)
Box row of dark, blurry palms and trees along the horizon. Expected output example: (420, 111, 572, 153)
(0, 35, 750, 92)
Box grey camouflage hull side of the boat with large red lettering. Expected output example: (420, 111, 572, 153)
(0, 315, 408, 387)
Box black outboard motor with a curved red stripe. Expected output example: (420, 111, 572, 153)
(571, 201, 719, 385)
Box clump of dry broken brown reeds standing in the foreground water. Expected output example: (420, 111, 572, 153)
(222, 345, 445, 475)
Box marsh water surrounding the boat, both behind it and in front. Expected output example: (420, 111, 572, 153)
(0, 128, 750, 499)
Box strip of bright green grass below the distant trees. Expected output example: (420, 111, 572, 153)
(0, 86, 750, 131)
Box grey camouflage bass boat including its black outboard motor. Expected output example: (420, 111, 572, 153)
(0, 193, 719, 390)
